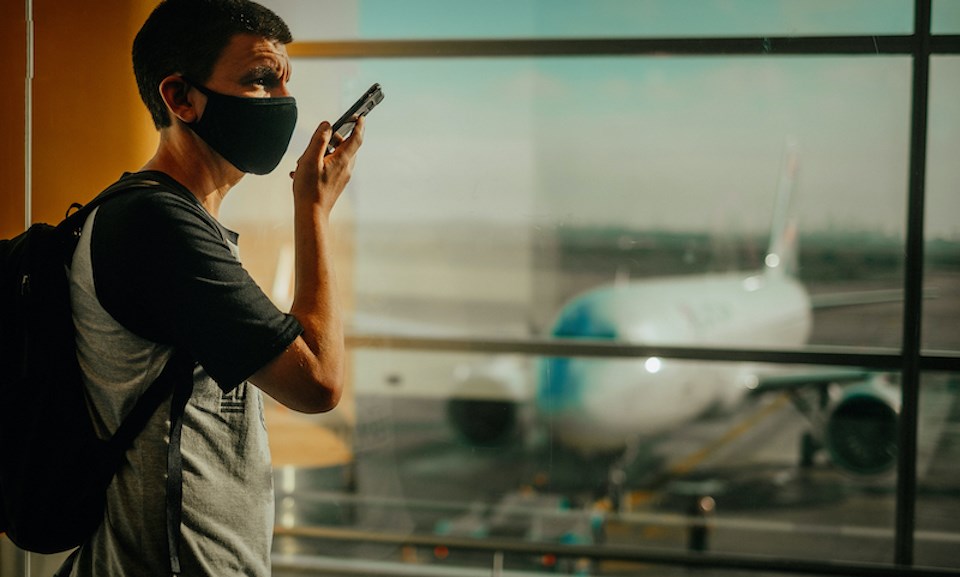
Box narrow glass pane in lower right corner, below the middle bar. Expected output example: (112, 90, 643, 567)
(915, 373, 960, 569)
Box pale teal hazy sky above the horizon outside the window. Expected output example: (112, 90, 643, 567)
(233, 0, 960, 240)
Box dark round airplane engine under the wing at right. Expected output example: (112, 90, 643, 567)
(821, 381, 899, 476)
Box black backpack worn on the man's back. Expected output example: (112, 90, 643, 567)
(0, 176, 192, 553)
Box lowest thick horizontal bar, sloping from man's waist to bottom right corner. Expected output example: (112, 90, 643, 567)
(274, 527, 960, 577)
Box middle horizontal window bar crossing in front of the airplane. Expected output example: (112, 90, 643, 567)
(347, 333, 960, 371)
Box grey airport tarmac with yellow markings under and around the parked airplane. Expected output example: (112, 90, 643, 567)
(275, 274, 960, 577)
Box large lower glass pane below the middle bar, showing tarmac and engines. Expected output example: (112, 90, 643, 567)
(276, 349, 912, 575)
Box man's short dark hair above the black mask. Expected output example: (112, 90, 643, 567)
(133, 0, 293, 129)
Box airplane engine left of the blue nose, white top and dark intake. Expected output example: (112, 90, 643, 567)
(447, 357, 527, 446)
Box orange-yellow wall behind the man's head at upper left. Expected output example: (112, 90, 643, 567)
(0, 0, 157, 237)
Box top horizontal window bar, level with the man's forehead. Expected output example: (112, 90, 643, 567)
(288, 35, 960, 58)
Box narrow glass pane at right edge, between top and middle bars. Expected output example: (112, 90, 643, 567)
(923, 56, 960, 351)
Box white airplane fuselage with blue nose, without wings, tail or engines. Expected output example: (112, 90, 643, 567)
(536, 271, 811, 452)
